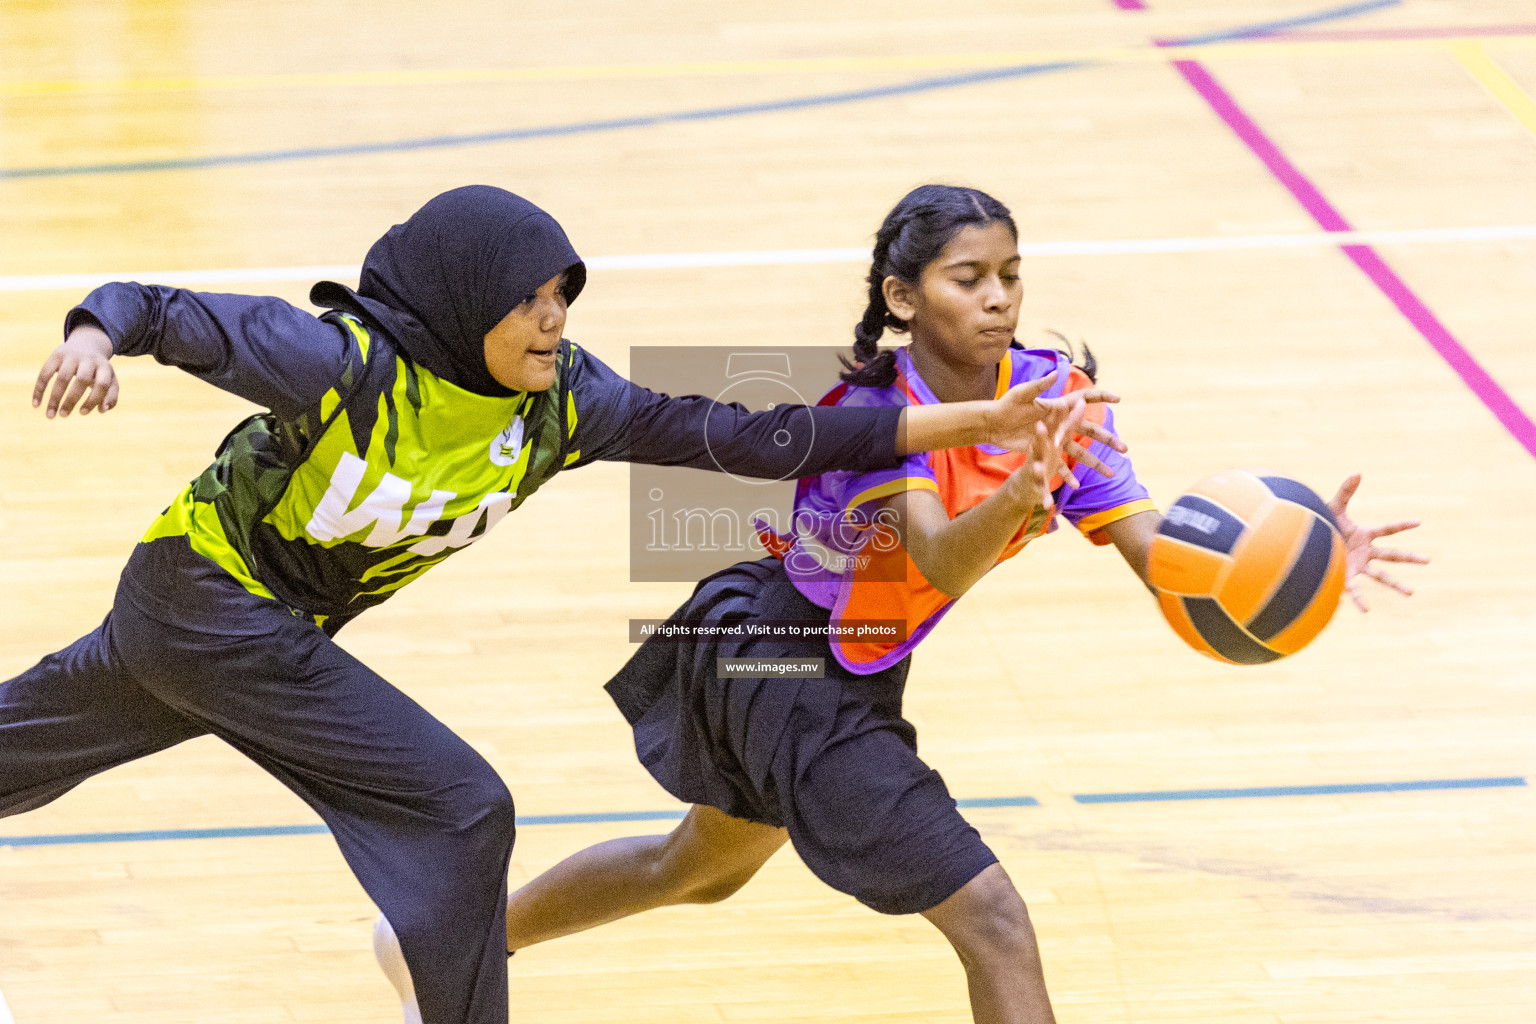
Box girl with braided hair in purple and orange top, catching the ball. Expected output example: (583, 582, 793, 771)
(376, 186, 1416, 1024)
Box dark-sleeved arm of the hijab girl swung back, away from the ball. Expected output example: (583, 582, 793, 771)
(32, 282, 352, 418)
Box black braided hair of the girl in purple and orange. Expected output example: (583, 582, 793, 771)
(842, 184, 1018, 387)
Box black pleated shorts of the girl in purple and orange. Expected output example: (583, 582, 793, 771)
(607, 559, 997, 913)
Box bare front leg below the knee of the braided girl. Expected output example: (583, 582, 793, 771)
(923, 864, 1055, 1024)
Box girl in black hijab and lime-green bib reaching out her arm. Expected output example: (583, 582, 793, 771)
(0, 186, 1107, 1024)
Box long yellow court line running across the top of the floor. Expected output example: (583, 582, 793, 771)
(0, 35, 1536, 97)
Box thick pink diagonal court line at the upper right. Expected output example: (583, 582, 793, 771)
(1172, 52, 1536, 457)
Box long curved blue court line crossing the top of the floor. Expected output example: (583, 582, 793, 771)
(0, 0, 1401, 181)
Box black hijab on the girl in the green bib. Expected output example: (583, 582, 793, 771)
(309, 184, 587, 398)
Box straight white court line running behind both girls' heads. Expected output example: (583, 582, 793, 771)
(0, 224, 1536, 290)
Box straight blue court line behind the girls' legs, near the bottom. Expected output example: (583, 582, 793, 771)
(0, 775, 1528, 847)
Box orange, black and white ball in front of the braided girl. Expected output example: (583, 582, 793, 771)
(1147, 470, 1346, 665)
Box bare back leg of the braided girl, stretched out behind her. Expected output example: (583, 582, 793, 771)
(507, 804, 788, 950)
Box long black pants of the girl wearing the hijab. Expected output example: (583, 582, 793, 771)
(0, 537, 513, 1024)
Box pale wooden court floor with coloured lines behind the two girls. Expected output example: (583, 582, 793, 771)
(0, 0, 1536, 1024)
